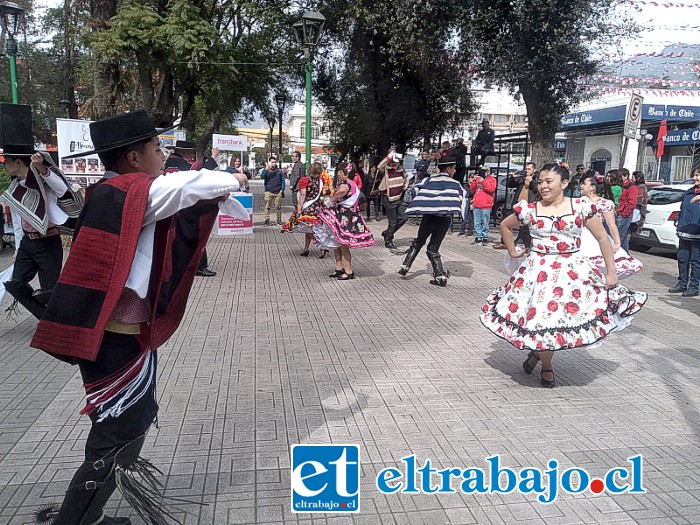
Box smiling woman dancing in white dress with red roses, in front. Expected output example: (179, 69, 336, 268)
(481, 164, 647, 388)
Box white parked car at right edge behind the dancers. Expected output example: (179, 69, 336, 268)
(630, 184, 693, 252)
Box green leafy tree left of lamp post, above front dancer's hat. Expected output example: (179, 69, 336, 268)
(87, 0, 296, 155)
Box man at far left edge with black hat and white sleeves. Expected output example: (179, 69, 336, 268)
(0, 144, 83, 318)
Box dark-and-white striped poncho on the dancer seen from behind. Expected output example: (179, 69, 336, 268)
(405, 173, 467, 217)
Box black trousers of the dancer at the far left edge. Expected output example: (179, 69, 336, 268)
(12, 235, 63, 290)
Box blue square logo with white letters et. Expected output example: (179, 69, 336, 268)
(291, 445, 360, 512)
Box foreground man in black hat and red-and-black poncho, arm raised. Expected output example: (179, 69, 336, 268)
(31, 110, 249, 525)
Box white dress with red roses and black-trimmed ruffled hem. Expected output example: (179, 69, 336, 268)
(481, 199, 647, 350)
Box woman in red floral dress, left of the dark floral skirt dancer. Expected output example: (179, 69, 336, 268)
(282, 162, 328, 259)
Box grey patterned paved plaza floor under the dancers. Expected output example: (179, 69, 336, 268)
(0, 183, 700, 525)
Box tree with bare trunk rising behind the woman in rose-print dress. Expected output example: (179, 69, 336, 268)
(460, 0, 629, 166)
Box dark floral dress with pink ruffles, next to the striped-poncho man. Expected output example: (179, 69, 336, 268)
(314, 180, 374, 248)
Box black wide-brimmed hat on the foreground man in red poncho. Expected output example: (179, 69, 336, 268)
(63, 109, 175, 159)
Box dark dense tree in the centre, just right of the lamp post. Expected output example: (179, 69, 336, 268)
(316, 0, 472, 156)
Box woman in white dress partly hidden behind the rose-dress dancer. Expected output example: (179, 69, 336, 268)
(581, 170, 644, 279)
